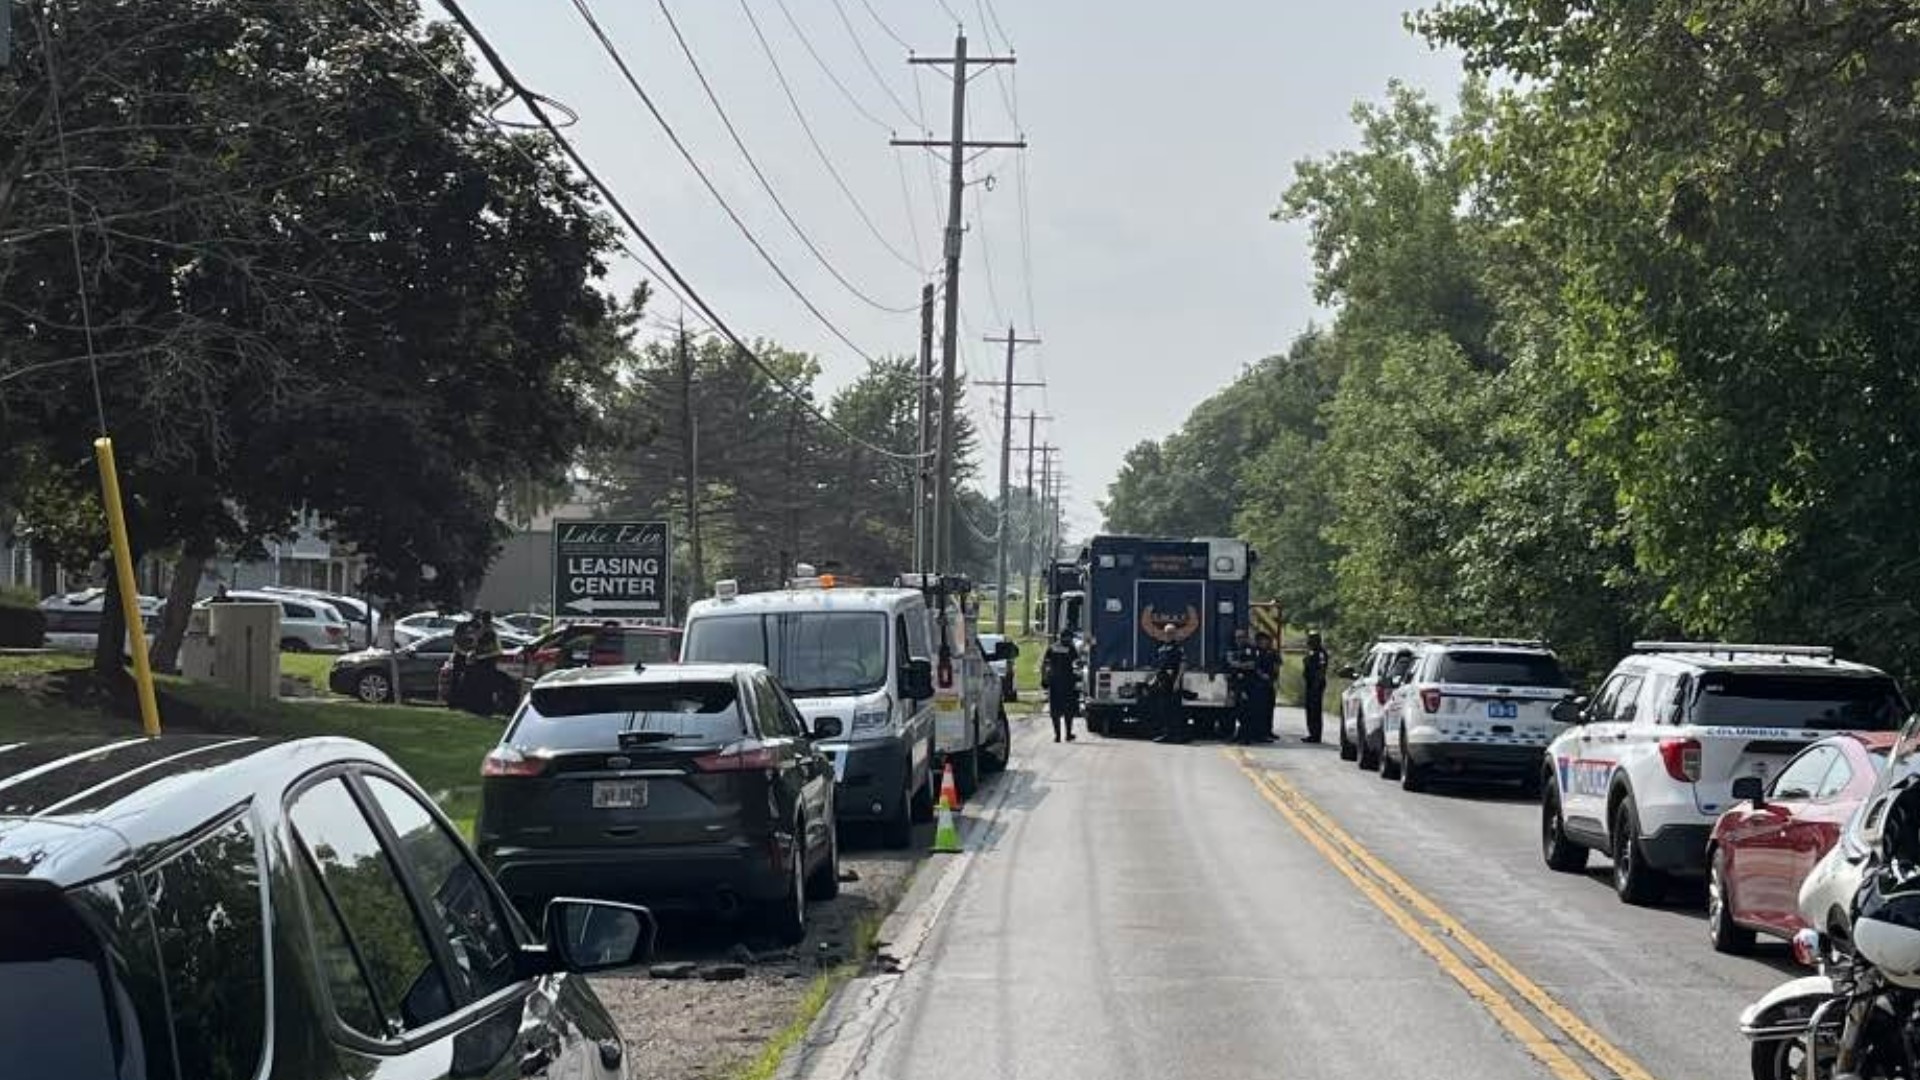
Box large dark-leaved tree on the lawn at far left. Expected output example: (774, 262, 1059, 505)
(0, 0, 614, 673)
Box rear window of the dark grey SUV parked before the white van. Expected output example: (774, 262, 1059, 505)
(522, 678, 751, 749)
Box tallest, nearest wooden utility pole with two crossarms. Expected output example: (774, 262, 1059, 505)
(893, 33, 1027, 571)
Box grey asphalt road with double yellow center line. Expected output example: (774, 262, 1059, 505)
(810, 711, 1797, 1080)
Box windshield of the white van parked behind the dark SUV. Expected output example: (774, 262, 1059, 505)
(682, 611, 887, 698)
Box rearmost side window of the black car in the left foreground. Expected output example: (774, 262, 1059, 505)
(142, 817, 267, 1080)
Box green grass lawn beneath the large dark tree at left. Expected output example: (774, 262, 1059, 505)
(0, 655, 501, 834)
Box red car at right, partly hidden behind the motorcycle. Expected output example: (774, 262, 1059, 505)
(1707, 732, 1899, 953)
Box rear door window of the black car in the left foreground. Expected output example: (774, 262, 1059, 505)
(288, 778, 453, 1034)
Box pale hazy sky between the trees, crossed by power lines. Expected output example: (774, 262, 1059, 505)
(460, 0, 1459, 536)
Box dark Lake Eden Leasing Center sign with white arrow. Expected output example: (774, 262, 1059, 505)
(553, 521, 674, 619)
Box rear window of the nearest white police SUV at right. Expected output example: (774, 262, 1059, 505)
(1693, 671, 1907, 732)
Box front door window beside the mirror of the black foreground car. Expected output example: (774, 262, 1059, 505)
(367, 776, 516, 1001)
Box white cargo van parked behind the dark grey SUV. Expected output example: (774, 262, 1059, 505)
(680, 578, 941, 847)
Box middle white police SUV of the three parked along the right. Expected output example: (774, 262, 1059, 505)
(1380, 638, 1572, 792)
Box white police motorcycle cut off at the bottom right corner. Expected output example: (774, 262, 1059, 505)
(1740, 719, 1920, 1080)
